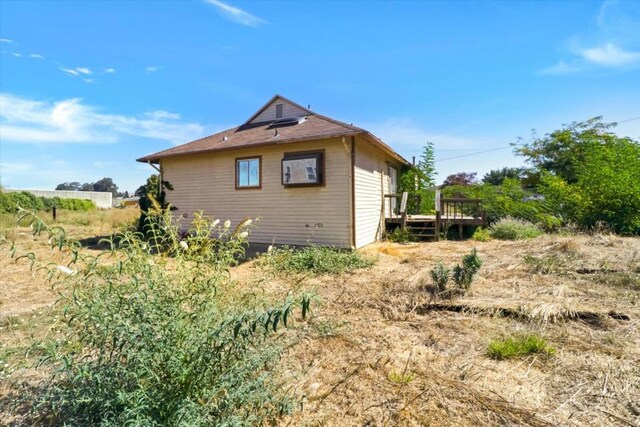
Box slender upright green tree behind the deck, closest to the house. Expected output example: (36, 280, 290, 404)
(398, 142, 436, 213)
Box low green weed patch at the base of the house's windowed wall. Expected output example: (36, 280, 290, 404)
(258, 246, 375, 274)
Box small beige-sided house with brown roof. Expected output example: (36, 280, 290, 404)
(138, 95, 409, 248)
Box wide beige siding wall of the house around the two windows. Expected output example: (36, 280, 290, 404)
(162, 139, 352, 247)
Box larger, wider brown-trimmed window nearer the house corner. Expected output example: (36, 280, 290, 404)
(282, 151, 324, 187)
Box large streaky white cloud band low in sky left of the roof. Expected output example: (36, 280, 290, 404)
(0, 94, 204, 144)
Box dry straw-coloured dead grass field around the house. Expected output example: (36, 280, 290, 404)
(0, 211, 640, 426)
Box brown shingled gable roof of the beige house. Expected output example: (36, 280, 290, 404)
(137, 95, 409, 164)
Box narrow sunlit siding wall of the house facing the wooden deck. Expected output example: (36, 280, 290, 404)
(354, 138, 399, 248)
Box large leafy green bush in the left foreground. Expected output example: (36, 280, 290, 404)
(4, 207, 310, 426)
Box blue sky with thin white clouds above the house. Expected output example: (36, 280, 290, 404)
(0, 0, 640, 191)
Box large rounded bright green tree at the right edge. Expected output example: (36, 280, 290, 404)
(519, 117, 640, 234)
